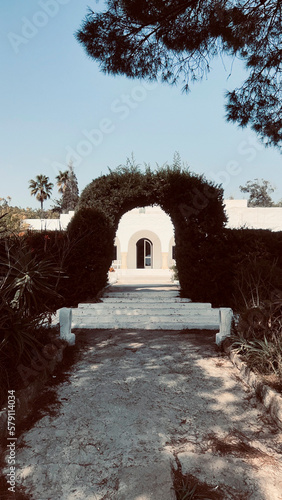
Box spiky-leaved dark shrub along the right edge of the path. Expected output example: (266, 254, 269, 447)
(232, 270, 282, 382)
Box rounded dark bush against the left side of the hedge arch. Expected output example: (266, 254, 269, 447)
(66, 208, 115, 304)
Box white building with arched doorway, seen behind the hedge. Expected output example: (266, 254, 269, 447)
(24, 200, 282, 269)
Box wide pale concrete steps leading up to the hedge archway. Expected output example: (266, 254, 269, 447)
(72, 284, 219, 330)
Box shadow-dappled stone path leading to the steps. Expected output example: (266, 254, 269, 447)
(13, 330, 282, 500)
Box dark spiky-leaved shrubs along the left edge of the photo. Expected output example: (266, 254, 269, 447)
(0, 236, 66, 404)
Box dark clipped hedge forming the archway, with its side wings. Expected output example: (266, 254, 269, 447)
(13, 164, 282, 309)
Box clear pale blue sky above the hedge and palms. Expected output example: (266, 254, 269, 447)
(0, 0, 282, 208)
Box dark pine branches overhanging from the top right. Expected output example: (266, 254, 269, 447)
(77, 0, 282, 147)
